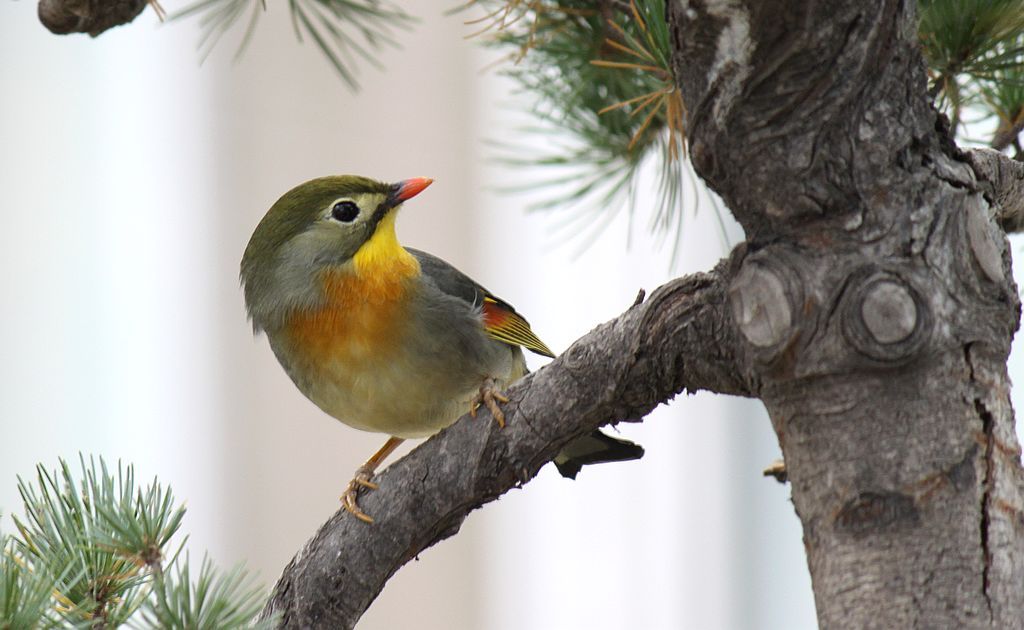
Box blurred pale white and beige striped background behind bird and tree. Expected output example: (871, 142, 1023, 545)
(0, 0, 983, 630)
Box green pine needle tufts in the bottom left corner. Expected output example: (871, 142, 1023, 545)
(0, 458, 270, 630)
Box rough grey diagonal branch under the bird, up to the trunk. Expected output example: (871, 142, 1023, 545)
(264, 261, 752, 628)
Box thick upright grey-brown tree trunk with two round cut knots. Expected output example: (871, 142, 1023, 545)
(669, 0, 1024, 628)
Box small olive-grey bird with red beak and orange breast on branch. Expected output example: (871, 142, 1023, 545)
(240, 175, 643, 522)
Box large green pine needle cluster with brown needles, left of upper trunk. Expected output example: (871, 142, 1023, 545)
(467, 0, 686, 250)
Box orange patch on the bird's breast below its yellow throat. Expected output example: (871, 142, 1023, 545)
(288, 259, 419, 366)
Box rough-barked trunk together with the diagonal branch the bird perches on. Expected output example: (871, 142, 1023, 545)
(253, 0, 1024, 628)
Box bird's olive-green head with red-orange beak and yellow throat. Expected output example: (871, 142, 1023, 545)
(241, 175, 432, 330)
